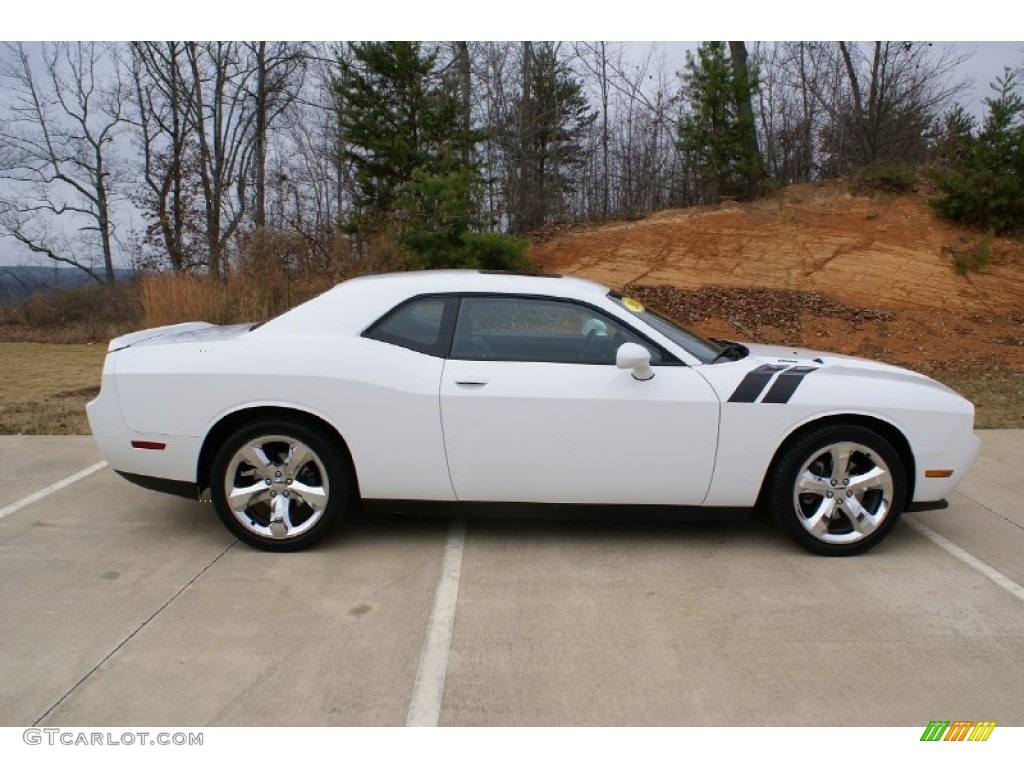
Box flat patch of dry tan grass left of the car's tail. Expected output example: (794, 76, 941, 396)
(0, 343, 106, 434)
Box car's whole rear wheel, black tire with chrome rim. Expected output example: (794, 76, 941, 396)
(210, 420, 351, 552)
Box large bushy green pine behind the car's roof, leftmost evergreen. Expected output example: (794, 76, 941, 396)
(335, 42, 525, 268)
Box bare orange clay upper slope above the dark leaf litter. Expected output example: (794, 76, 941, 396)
(531, 183, 1024, 311)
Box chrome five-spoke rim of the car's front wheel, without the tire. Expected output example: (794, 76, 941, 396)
(793, 442, 894, 544)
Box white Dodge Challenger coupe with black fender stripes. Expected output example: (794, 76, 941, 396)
(87, 270, 980, 555)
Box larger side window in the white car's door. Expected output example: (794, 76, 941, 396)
(452, 296, 662, 365)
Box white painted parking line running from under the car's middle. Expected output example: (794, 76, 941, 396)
(406, 520, 466, 726)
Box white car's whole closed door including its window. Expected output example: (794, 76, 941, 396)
(440, 295, 719, 505)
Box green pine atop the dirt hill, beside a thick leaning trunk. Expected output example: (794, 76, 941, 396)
(678, 42, 762, 202)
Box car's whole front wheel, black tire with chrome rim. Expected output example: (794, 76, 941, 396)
(764, 424, 908, 556)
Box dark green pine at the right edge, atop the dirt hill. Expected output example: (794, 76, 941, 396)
(932, 70, 1024, 233)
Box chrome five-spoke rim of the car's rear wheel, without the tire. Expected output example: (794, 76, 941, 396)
(224, 434, 330, 540)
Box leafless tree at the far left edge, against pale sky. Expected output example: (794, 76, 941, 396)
(0, 42, 128, 283)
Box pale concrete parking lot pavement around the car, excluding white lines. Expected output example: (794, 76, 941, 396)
(0, 431, 1024, 727)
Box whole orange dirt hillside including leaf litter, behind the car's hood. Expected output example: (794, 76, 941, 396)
(530, 183, 1024, 427)
